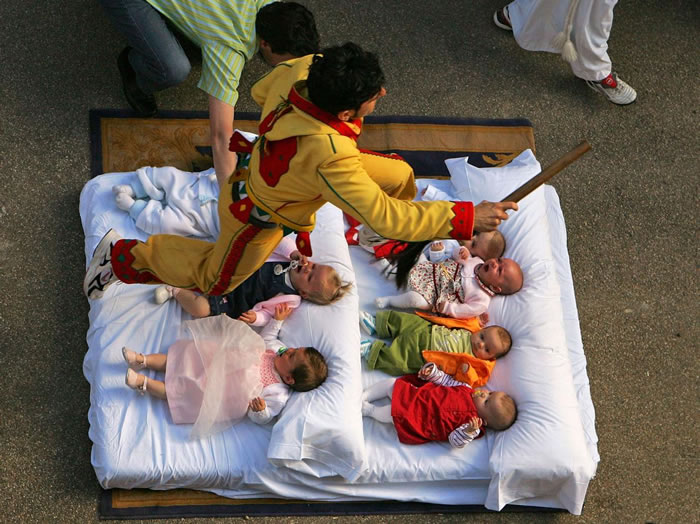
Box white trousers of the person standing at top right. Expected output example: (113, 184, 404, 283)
(508, 0, 617, 82)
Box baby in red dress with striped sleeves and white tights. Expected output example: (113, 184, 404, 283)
(362, 363, 517, 448)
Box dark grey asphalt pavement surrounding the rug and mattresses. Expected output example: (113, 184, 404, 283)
(0, 0, 700, 523)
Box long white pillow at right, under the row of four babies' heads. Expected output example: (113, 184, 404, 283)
(445, 150, 595, 508)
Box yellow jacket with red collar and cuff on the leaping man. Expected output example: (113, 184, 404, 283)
(246, 55, 474, 245)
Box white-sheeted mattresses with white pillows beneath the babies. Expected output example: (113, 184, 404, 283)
(80, 154, 598, 514)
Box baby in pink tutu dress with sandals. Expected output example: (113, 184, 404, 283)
(122, 304, 328, 437)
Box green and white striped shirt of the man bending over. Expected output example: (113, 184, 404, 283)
(147, 0, 275, 106)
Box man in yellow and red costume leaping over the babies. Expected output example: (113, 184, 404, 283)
(83, 43, 517, 298)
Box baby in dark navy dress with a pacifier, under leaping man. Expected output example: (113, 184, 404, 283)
(155, 236, 352, 326)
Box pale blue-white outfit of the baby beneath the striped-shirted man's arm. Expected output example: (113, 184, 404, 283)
(135, 167, 219, 238)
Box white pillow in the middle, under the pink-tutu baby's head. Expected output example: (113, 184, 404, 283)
(267, 204, 366, 481)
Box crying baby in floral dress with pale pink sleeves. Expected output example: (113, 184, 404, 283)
(375, 246, 523, 318)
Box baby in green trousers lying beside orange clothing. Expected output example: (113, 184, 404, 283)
(360, 310, 512, 386)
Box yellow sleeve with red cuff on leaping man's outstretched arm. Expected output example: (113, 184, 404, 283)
(318, 143, 474, 242)
